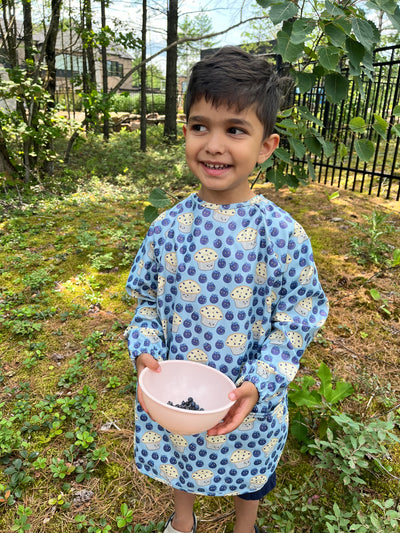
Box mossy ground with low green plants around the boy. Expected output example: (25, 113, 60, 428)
(0, 127, 400, 533)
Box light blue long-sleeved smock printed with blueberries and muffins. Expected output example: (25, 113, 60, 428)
(127, 194, 328, 496)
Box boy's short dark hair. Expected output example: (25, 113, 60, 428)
(185, 46, 281, 137)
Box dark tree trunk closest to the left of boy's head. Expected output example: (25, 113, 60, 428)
(164, 0, 178, 140)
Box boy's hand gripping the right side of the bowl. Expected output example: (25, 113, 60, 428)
(207, 381, 258, 435)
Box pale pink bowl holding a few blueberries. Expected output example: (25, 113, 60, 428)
(139, 360, 236, 435)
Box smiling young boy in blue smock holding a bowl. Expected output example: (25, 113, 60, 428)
(127, 47, 328, 533)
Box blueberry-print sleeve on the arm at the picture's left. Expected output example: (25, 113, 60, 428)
(125, 227, 166, 360)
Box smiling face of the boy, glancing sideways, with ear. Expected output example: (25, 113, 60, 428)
(183, 98, 279, 204)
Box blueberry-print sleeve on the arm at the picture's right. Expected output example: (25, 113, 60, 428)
(239, 227, 328, 415)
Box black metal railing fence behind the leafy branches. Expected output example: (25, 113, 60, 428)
(296, 45, 400, 200)
